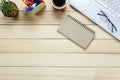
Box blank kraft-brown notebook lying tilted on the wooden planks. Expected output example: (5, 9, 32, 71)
(58, 15, 95, 49)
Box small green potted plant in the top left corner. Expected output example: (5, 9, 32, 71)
(0, 0, 19, 17)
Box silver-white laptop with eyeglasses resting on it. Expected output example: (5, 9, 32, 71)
(70, 0, 120, 40)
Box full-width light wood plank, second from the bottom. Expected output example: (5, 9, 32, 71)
(0, 53, 120, 68)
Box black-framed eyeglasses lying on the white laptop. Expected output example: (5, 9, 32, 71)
(98, 10, 117, 33)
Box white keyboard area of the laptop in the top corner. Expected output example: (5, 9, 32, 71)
(96, 0, 120, 17)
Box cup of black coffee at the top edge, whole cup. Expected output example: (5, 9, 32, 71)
(51, 0, 67, 10)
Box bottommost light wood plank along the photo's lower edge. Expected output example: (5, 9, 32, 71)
(0, 67, 120, 80)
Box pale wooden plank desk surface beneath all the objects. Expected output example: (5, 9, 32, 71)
(0, 0, 120, 80)
